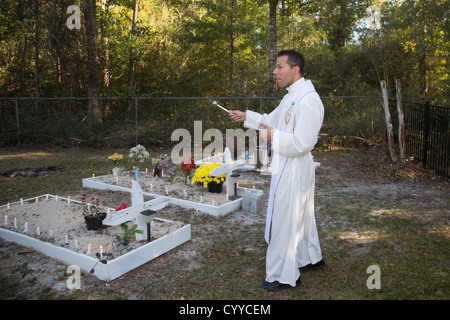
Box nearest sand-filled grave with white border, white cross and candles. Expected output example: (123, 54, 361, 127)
(0, 182, 191, 281)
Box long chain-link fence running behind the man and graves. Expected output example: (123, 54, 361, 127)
(0, 96, 385, 147)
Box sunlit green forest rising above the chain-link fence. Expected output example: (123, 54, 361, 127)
(0, 0, 450, 148)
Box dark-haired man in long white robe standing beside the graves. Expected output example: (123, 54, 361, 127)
(230, 50, 325, 291)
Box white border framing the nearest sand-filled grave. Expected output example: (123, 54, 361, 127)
(0, 194, 191, 282)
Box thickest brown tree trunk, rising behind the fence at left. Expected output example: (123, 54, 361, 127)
(85, 0, 103, 124)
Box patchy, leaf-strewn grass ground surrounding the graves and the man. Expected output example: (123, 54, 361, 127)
(0, 149, 450, 300)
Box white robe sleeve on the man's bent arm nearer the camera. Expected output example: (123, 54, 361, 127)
(273, 94, 324, 158)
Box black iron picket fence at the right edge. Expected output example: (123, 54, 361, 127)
(403, 101, 450, 179)
